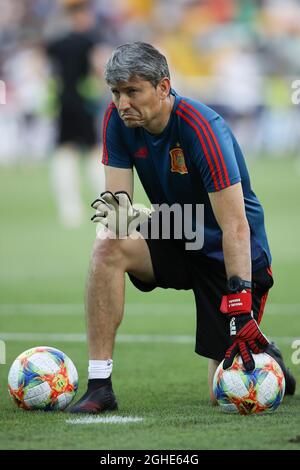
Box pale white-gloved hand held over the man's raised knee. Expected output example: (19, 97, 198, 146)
(91, 191, 151, 238)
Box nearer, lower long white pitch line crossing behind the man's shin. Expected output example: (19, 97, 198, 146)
(0, 332, 299, 344)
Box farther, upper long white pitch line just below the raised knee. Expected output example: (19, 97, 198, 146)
(0, 303, 300, 317)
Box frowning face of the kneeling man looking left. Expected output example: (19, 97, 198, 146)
(111, 78, 166, 128)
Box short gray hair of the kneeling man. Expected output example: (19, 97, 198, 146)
(104, 42, 170, 87)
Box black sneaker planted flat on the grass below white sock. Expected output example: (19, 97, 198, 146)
(66, 383, 118, 414)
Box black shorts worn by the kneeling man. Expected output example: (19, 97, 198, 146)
(129, 239, 273, 361)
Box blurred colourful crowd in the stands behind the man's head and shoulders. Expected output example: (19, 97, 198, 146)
(0, 0, 300, 162)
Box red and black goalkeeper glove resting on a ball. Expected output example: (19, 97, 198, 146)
(220, 276, 269, 371)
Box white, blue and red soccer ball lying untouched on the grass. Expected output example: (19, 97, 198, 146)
(8, 346, 78, 411)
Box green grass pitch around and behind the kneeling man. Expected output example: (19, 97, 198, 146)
(0, 159, 300, 450)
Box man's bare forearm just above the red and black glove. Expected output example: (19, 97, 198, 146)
(223, 222, 251, 281)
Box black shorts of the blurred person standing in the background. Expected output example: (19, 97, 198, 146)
(57, 108, 99, 148)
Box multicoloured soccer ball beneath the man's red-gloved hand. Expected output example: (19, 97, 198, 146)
(213, 353, 285, 415)
